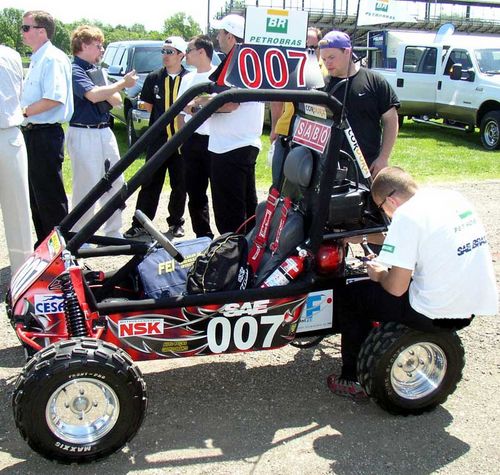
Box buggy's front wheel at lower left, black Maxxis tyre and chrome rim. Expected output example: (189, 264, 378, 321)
(12, 338, 147, 463)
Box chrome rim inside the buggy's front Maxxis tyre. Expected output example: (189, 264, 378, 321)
(45, 378, 120, 444)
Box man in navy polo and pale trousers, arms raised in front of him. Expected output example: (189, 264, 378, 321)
(66, 25, 137, 237)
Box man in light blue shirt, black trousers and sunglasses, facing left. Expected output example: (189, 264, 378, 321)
(21, 11, 73, 247)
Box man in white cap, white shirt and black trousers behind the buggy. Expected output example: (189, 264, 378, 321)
(208, 14, 264, 234)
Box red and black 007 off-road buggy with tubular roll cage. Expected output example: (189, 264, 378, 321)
(7, 44, 464, 463)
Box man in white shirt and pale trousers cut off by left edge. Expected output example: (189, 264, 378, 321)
(0, 45, 33, 275)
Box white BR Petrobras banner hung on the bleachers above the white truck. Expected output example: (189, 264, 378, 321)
(358, 0, 417, 25)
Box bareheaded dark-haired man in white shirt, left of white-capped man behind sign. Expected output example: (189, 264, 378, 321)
(179, 35, 216, 238)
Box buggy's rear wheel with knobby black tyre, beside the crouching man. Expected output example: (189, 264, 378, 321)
(358, 322, 465, 415)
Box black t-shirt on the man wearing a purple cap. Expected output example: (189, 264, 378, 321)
(324, 68, 399, 165)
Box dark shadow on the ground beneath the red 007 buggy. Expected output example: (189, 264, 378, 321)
(0, 343, 469, 474)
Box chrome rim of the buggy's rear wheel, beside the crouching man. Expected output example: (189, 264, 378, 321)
(391, 342, 447, 400)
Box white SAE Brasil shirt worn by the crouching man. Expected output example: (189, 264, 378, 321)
(378, 189, 498, 318)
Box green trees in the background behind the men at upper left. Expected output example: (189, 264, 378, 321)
(0, 8, 202, 56)
